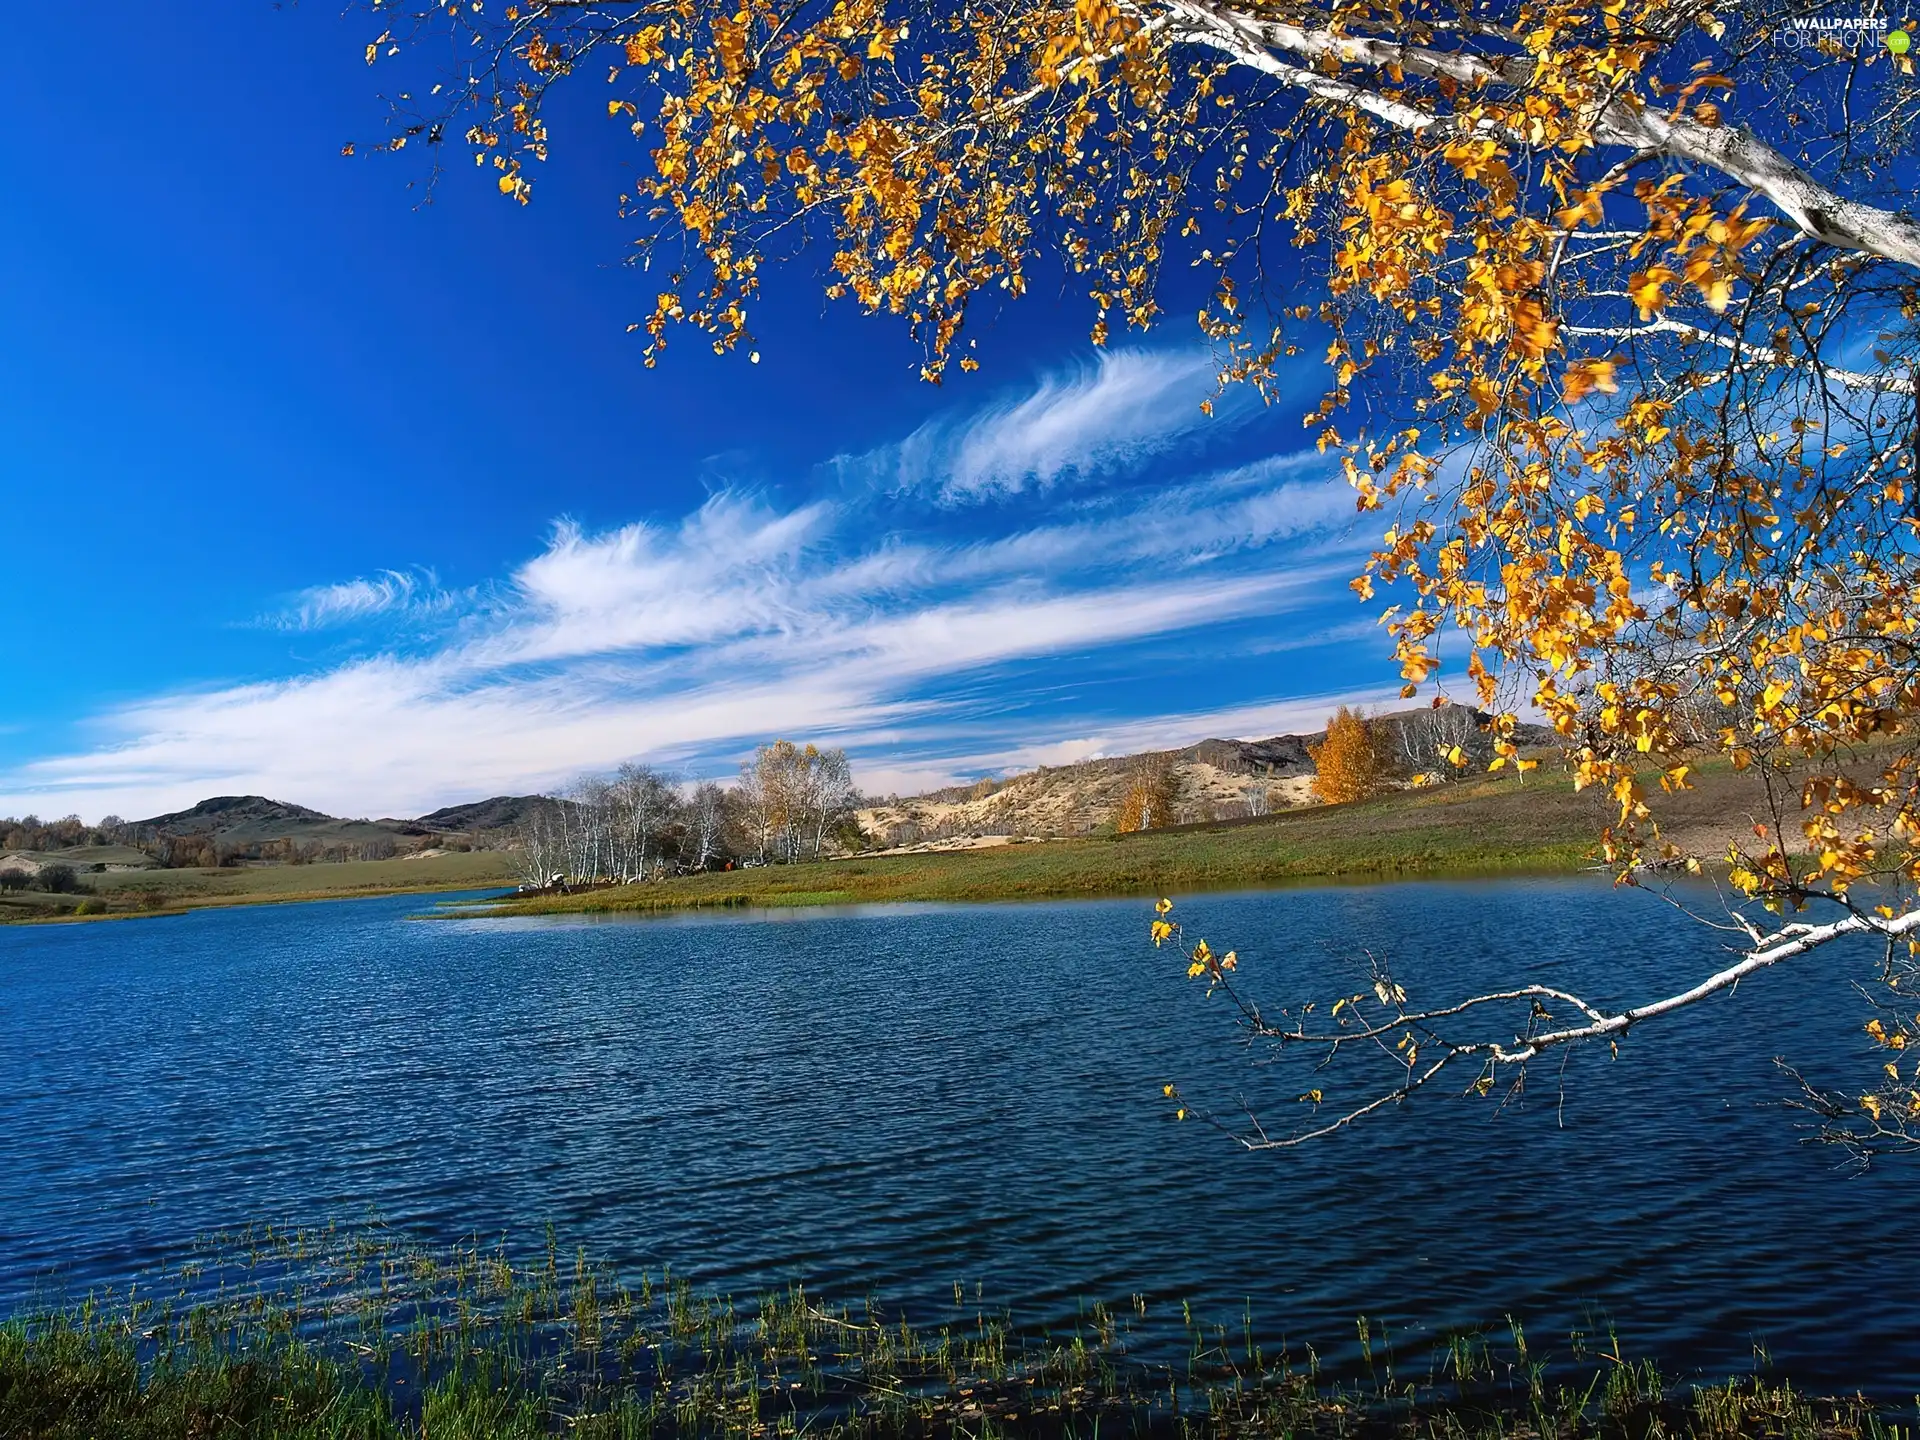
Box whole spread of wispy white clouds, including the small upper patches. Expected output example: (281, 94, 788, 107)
(0, 362, 1382, 816)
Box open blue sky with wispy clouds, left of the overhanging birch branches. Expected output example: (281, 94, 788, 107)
(0, 0, 1396, 820)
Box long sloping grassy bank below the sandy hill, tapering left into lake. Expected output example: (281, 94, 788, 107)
(476, 778, 1603, 914)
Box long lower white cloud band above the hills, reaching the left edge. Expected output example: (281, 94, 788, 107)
(0, 551, 1328, 816)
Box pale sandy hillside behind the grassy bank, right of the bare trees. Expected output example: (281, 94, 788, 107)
(860, 707, 1551, 849)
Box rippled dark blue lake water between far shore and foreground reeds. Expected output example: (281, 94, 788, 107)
(0, 881, 1920, 1398)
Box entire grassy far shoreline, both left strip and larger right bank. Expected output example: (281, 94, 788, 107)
(0, 762, 1781, 924)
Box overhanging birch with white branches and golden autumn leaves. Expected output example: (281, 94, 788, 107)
(367, 0, 1920, 1148)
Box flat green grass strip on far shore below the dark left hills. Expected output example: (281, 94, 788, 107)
(0, 851, 513, 922)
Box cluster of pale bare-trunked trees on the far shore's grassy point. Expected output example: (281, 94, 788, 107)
(515, 739, 860, 885)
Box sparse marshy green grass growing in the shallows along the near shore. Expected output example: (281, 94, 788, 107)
(0, 1229, 1910, 1440)
